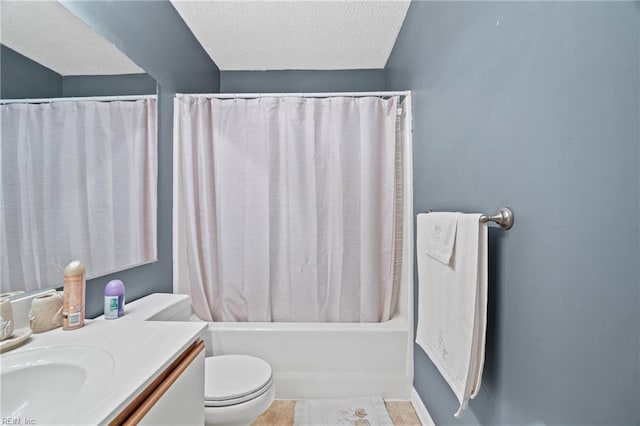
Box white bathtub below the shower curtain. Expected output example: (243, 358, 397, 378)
(192, 315, 413, 399)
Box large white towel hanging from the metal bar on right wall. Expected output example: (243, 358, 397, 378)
(416, 213, 487, 418)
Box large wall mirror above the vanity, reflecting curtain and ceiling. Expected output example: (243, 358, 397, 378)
(0, 0, 157, 294)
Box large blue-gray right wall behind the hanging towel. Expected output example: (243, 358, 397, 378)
(386, 2, 640, 425)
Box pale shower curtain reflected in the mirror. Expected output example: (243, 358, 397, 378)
(0, 99, 157, 291)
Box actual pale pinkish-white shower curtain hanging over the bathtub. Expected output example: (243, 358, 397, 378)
(174, 95, 398, 322)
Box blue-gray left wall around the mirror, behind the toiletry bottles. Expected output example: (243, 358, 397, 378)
(62, 0, 220, 317)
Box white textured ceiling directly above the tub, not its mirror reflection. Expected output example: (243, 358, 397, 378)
(171, 0, 409, 71)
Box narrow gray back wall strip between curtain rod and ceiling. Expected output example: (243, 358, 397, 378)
(220, 70, 384, 93)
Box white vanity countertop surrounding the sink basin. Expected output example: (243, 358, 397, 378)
(0, 319, 206, 425)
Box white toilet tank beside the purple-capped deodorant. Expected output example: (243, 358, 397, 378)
(114, 293, 191, 321)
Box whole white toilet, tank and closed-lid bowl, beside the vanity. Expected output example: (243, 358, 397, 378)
(118, 293, 276, 426)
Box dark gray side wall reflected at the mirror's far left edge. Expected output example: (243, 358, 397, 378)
(0, 44, 62, 99)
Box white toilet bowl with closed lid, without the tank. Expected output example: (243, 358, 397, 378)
(204, 355, 275, 426)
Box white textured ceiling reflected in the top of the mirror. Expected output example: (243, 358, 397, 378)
(0, 0, 144, 75)
